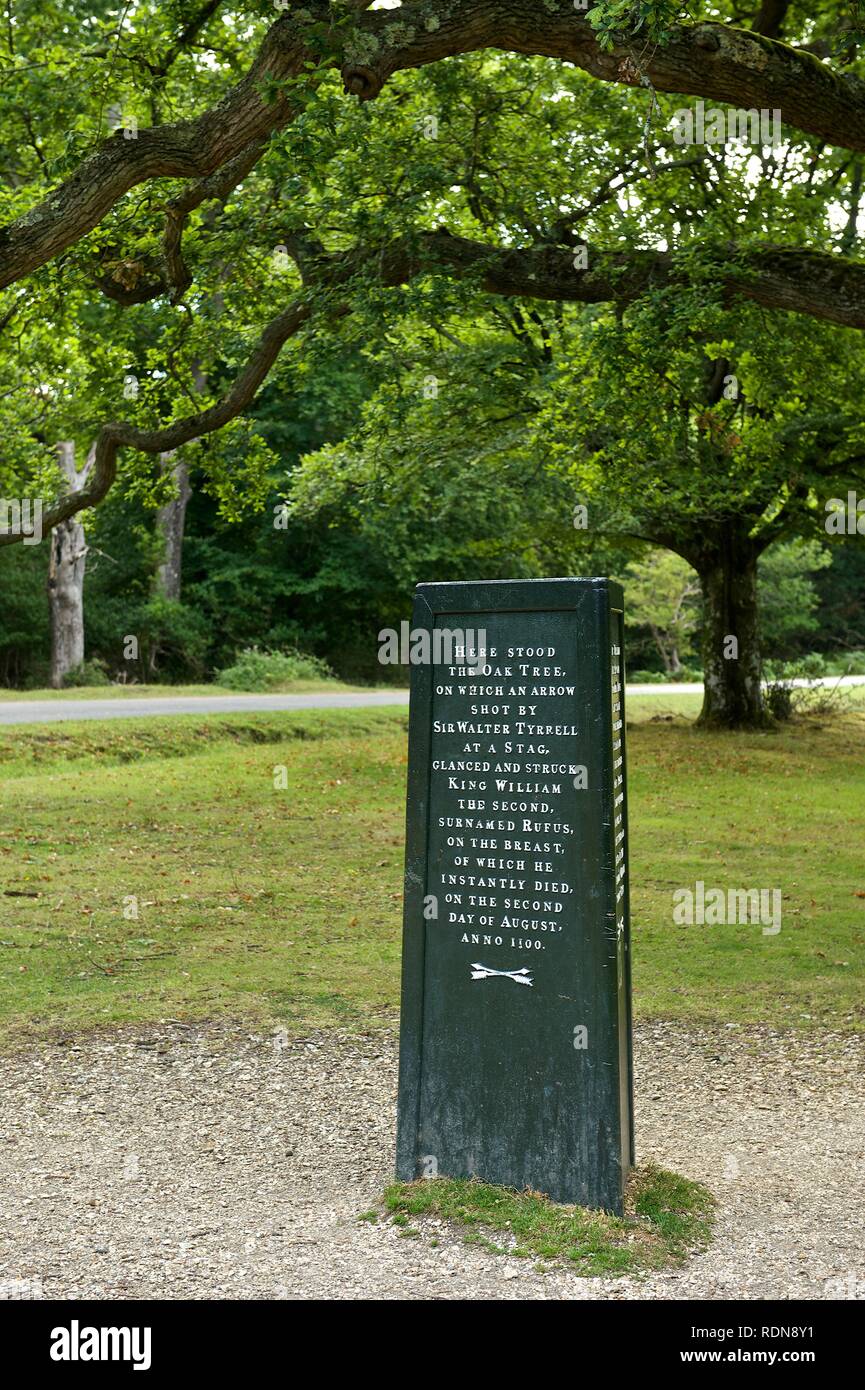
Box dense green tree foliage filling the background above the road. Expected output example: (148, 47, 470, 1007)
(0, 0, 865, 706)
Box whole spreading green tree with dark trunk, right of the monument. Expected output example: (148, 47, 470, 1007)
(292, 262, 865, 727)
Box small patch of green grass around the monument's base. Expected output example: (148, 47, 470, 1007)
(384, 1163, 715, 1276)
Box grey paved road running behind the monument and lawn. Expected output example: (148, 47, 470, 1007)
(0, 676, 865, 724)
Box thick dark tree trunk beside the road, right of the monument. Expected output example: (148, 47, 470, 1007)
(695, 531, 772, 728)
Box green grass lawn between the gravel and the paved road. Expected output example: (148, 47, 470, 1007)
(0, 696, 865, 1043)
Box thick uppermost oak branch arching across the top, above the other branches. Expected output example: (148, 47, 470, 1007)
(0, 0, 865, 296)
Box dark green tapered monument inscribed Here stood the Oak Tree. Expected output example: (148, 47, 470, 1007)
(396, 580, 634, 1212)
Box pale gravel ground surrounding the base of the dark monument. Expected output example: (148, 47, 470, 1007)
(0, 1023, 865, 1300)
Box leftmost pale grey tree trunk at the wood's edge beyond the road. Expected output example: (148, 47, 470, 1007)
(47, 443, 92, 689)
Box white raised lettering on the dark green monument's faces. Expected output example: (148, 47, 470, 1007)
(430, 631, 624, 986)
